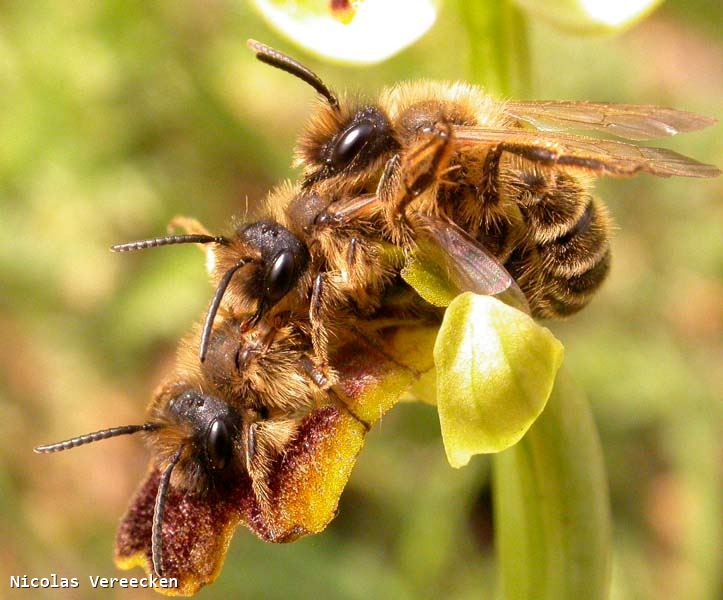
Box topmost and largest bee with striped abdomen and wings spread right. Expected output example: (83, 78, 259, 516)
(249, 40, 720, 318)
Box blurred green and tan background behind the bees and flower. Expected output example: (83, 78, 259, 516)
(0, 0, 723, 600)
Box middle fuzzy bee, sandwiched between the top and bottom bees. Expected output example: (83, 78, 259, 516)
(111, 182, 398, 381)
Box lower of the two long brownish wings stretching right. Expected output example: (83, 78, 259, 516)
(454, 126, 720, 177)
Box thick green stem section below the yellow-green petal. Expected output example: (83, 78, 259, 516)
(493, 371, 610, 600)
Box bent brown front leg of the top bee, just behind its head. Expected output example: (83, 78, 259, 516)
(377, 121, 452, 246)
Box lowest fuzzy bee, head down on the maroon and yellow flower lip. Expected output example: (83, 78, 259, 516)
(35, 318, 341, 577)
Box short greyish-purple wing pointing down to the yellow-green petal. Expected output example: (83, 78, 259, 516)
(416, 215, 529, 312)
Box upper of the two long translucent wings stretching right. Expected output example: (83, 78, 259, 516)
(504, 100, 716, 141)
